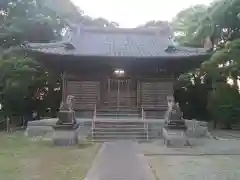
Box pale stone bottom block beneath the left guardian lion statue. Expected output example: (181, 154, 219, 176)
(53, 130, 78, 146)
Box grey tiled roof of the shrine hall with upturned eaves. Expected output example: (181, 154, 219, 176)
(25, 27, 210, 57)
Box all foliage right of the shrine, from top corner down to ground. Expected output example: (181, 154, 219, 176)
(173, 0, 240, 128)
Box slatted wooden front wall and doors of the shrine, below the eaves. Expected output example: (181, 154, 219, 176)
(63, 74, 173, 110)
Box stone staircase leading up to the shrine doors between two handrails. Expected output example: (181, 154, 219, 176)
(91, 108, 148, 141)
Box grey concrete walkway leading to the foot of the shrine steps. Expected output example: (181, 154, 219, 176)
(85, 141, 155, 180)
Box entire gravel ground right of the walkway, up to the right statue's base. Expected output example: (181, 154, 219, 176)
(140, 132, 240, 180)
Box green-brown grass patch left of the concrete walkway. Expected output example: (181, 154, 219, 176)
(0, 133, 100, 180)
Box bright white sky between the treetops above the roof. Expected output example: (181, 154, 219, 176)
(72, 0, 212, 28)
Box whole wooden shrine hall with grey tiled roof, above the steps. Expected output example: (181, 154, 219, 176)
(26, 25, 208, 116)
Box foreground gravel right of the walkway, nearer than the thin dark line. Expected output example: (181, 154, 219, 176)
(146, 156, 240, 180)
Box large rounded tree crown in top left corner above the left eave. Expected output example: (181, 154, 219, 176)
(0, 0, 64, 48)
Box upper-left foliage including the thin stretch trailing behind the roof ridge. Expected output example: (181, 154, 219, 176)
(0, 0, 118, 48)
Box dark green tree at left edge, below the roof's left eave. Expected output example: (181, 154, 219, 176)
(0, 54, 37, 121)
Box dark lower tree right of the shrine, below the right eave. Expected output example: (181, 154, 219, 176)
(175, 39, 240, 128)
